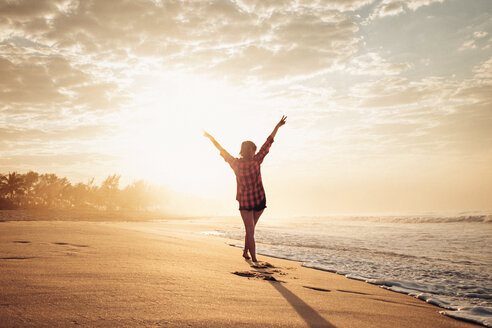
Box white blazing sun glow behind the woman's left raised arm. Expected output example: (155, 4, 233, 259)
(115, 73, 266, 196)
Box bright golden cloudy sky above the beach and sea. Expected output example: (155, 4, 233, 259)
(0, 0, 492, 216)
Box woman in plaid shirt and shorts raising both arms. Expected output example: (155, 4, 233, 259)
(204, 116, 287, 262)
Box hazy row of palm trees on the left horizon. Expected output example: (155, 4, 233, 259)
(0, 171, 162, 211)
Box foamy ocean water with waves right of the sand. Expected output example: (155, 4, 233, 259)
(207, 214, 492, 327)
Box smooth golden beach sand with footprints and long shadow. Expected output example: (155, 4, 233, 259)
(0, 211, 477, 327)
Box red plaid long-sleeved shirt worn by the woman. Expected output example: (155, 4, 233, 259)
(220, 136, 273, 208)
